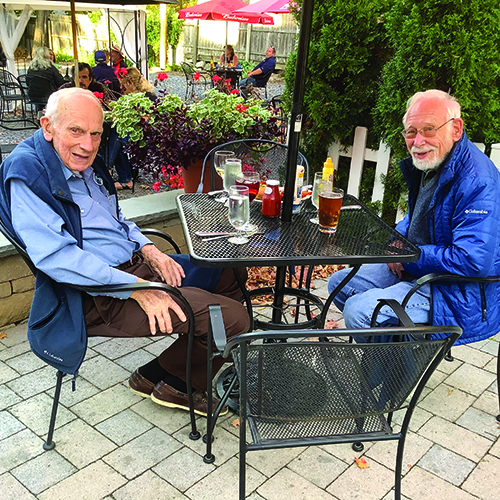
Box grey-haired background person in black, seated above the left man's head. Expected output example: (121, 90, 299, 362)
(26, 47, 64, 111)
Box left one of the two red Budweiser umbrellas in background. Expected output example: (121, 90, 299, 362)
(179, 0, 274, 50)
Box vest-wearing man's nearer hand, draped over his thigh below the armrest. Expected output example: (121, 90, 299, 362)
(130, 278, 186, 335)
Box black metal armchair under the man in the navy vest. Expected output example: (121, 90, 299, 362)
(0, 219, 205, 450)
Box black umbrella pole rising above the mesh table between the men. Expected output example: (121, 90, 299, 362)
(281, 0, 314, 222)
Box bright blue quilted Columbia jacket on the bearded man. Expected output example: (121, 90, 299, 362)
(396, 131, 500, 344)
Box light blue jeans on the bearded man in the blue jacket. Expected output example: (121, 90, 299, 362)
(328, 264, 430, 328)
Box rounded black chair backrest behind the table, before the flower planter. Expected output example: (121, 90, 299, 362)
(198, 139, 309, 193)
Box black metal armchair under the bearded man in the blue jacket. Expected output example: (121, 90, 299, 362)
(371, 273, 500, 422)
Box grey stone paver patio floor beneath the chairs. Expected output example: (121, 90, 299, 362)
(0, 281, 500, 500)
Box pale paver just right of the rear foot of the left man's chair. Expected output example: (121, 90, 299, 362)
(54, 420, 116, 469)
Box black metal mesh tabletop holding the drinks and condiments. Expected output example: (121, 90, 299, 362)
(177, 194, 419, 267)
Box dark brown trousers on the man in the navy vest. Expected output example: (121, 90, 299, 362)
(84, 254, 250, 391)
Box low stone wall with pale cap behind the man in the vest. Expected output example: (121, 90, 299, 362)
(0, 191, 187, 328)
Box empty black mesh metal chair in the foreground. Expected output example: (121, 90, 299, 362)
(204, 306, 462, 500)
